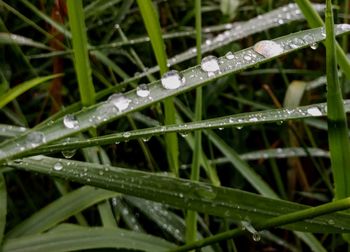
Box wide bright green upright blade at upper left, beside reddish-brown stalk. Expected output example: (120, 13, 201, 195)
(67, 0, 95, 106)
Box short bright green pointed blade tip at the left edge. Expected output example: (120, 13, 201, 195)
(0, 74, 63, 108)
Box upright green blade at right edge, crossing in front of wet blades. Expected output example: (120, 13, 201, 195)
(326, 0, 350, 199)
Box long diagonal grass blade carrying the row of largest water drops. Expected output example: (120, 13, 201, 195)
(0, 25, 350, 162)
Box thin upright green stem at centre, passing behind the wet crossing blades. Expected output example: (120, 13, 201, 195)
(186, 0, 202, 243)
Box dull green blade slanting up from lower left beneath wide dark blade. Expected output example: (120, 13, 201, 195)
(6, 185, 117, 239)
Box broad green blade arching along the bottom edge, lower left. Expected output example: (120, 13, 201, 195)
(2, 227, 174, 252)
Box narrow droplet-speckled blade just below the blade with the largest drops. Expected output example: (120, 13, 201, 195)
(28, 100, 350, 155)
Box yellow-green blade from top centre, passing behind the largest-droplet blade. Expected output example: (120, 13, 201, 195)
(137, 0, 179, 176)
